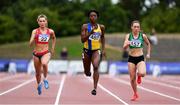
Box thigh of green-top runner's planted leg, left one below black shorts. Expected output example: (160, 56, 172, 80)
(128, 62, 136, 78)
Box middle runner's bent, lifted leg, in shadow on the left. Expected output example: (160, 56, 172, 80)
(82, 52, 91, 76)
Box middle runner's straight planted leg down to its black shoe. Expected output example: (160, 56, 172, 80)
(92, 50, 101, 95)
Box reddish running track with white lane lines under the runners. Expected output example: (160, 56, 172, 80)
(0, 73, 180, 105)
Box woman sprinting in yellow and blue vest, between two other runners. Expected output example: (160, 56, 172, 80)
(81, 10, 105, 95)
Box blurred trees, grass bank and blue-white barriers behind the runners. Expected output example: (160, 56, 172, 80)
(0, 0, 180, 75)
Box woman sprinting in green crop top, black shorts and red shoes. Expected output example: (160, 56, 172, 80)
(123, 20, 151, 101)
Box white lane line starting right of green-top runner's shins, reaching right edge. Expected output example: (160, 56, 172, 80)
(144, 79, 180, 90)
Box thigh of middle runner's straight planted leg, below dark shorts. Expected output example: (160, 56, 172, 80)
(92, 50, 101, 67)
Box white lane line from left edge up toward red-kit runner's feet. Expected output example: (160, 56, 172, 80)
(0, 78, 35, 96)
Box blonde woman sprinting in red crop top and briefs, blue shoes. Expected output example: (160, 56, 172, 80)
(29, 14, 56, 95)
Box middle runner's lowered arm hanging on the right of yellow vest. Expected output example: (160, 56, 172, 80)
(100, 25, 106, 57)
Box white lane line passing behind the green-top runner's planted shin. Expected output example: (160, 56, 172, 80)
(112, 77, 180, 101)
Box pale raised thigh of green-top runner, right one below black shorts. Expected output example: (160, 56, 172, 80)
(137, 61, 146, 74)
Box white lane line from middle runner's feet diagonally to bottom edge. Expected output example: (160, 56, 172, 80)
(89, 78, 129, 105)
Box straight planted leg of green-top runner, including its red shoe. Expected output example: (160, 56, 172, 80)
(128, 62, 138, 101)
